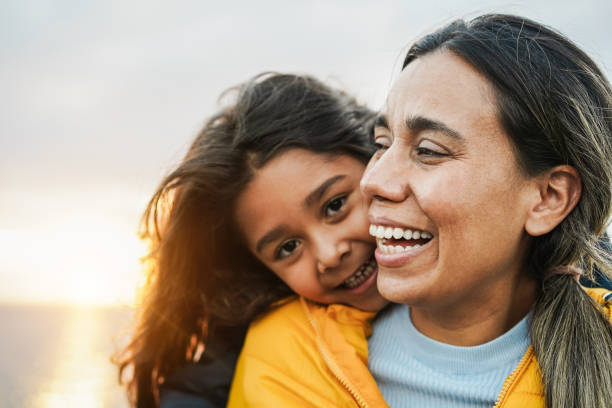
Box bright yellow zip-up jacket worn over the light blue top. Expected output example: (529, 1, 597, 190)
(228, 289, 612, 408)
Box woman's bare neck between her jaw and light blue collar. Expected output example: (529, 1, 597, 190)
(410, 277, 539, 346)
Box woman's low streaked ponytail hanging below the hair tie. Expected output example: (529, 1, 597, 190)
(530, 274, 612, 408)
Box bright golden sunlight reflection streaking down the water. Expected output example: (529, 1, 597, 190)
(28, 308, 133, 408)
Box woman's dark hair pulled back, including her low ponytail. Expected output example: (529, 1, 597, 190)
(403, 14, 612, 408)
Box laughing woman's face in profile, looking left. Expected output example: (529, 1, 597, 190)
(362, 51, 536, 310)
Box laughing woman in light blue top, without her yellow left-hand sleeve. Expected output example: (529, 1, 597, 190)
(362, 15, 612, 408)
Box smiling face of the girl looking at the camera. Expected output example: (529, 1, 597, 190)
(236, 149, 386, 311)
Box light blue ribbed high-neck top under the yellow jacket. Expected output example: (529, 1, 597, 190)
(368, 305, 530, 408)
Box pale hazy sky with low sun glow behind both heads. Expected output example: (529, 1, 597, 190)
(0, 0, 612, 305)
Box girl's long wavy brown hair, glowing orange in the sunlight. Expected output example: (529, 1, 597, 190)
(115, 73, 374, 407)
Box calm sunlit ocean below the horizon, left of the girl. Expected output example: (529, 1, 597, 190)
(0, 304, 132, 408)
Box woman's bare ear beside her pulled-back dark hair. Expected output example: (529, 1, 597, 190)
(525, 165, 582, 236)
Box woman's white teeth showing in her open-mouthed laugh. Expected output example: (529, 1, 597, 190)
(370, 224, 433, 254)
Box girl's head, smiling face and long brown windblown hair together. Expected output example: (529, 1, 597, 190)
(119, 74, 386, 406)
